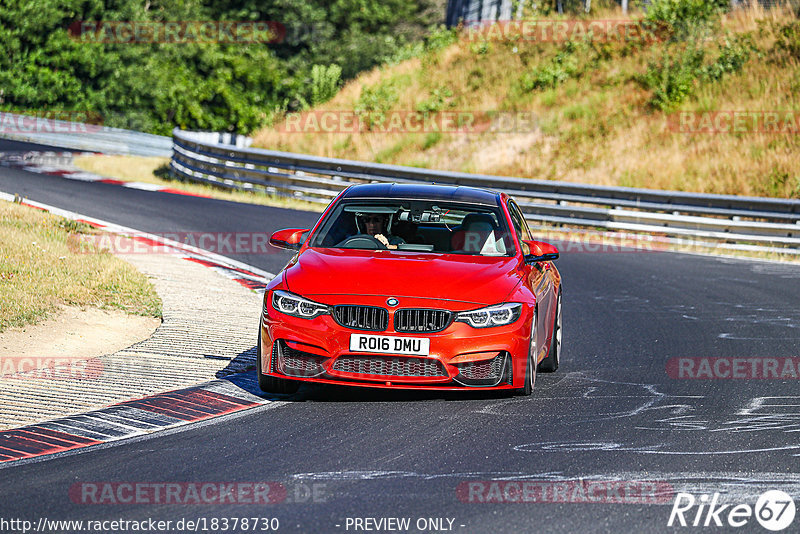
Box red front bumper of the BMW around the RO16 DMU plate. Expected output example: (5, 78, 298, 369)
(260, 296, 532, 390)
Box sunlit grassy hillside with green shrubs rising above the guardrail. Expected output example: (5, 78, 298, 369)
(255, 0, 800, 197)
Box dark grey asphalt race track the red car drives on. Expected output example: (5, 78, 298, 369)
(0, 139, 800, 532)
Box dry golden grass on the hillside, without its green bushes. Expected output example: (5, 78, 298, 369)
(255, 3, 800, 198)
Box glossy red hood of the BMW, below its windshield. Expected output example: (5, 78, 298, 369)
(284, 248, 520, 304)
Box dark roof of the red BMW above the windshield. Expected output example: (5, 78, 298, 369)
(342, 183, 500, 206)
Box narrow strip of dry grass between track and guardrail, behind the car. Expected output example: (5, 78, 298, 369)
(73, 155, 325, 212)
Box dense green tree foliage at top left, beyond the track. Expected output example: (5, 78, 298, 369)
(0, 0, 444, 134)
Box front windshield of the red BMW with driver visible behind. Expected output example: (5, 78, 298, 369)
(311, 200, 515, 256)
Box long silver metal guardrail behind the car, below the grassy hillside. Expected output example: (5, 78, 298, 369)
(170, 129, 800, 254)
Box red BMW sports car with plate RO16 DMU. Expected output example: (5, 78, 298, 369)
(257, 184, 561, 395)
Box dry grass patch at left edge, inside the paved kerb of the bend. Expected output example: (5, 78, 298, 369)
(0, 201, 161, 332)
